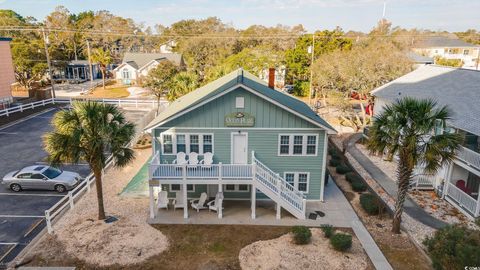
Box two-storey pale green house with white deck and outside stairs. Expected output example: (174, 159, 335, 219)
(146, 69, 336, 220)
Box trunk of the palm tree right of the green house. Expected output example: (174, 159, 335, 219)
(392, 154, 413, 234)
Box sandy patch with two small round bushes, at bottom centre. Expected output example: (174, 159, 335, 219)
(238, 228, 368, 270)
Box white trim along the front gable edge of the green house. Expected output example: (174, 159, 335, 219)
(145, 83, 337, 134)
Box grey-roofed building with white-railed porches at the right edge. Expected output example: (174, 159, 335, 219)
(372, 65, 480, 217)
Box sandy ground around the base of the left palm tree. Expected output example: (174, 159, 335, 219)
(28, 149, 168, 266)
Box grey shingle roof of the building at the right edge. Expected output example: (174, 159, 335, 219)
(372, 65, 480, 135)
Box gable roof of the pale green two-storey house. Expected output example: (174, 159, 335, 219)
(145, 69, 336, 133)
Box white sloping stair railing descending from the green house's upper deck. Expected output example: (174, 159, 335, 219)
(252, 154, 306, 216)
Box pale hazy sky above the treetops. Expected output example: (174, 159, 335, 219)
(0, 0, 480, 32)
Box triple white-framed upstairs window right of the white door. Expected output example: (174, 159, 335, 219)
(278, 134, 318, 156)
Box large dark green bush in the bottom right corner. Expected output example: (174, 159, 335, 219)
(423, 225, 480, 270)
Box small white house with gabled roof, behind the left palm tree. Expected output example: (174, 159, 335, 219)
(113, 53, 185, 85)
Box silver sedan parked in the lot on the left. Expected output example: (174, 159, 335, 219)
(2, 165, 81, 192)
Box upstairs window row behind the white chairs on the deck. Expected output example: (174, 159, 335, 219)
(161, 133, 213, 155)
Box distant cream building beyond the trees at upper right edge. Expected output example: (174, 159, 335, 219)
(413, 36, 480, 69)
